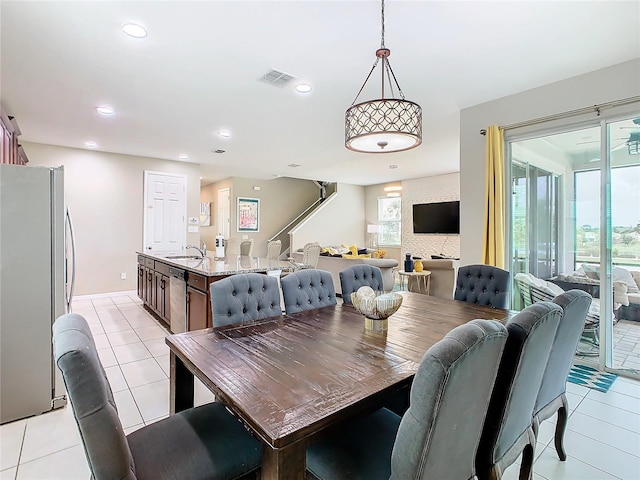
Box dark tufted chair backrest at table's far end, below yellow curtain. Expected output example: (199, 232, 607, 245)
(453, 265, 511, 308)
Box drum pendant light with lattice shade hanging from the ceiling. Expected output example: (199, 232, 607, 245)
(344, 0, 422, 153)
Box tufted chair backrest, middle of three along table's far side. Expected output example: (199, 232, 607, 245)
(280, 269, 337, 314)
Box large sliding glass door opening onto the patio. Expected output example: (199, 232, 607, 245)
(507, 114, 640, 376)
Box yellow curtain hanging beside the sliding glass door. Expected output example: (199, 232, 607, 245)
(482, 125, 505, 268)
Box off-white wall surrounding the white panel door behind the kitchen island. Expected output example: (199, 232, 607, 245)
(23, 142, 200, 295)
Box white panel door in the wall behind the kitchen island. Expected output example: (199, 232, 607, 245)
(144, 170, 187, 252)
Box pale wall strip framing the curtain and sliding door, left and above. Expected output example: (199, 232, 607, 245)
(460, 59, 640, 264)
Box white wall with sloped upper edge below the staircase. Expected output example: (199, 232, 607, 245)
(291, 183, 367, 251)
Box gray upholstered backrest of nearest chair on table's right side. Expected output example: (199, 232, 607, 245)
(391, 320, 507, 480)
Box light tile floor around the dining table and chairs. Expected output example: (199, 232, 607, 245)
(0, 294, 640, 480)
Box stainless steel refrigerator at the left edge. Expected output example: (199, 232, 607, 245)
(0, 165, 73, 423)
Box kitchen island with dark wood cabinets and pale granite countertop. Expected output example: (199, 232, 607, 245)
(137, 252, 295, 333)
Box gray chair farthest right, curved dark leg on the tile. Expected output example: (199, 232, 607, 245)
(533, 290, 591, 461)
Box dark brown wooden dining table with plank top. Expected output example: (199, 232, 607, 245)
(166, 292, 513, 479)
